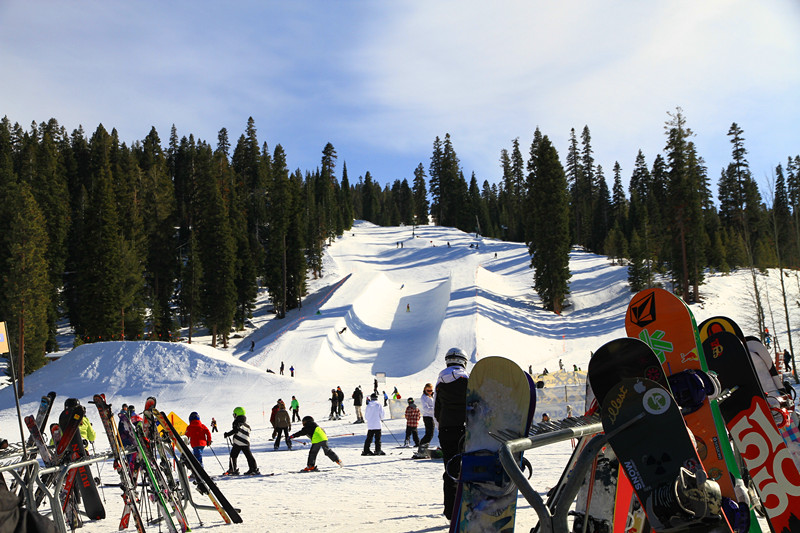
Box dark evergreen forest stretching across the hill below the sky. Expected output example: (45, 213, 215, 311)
(0, 108, 800, 386)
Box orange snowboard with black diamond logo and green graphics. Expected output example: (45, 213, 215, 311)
(625, 288, 757, 516)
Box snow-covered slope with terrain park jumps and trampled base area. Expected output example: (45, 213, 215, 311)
(0, 222, 800, 532)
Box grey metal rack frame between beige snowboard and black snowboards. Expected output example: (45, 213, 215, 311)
(495, 417, 608, 533)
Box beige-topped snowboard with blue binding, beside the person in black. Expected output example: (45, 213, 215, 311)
(450, 357, 536, 533)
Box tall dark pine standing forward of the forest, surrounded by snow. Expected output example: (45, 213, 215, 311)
(529, 136, 570, 314)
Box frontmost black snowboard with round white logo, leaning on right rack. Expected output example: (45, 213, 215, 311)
(601, 378, 731, 532)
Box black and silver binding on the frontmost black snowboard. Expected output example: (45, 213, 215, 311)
(645, 467, 722, 532)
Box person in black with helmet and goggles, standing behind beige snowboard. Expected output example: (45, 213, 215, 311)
(433, 348, 469, 520)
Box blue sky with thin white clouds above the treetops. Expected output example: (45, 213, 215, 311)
(0, 0, 800, 192)
